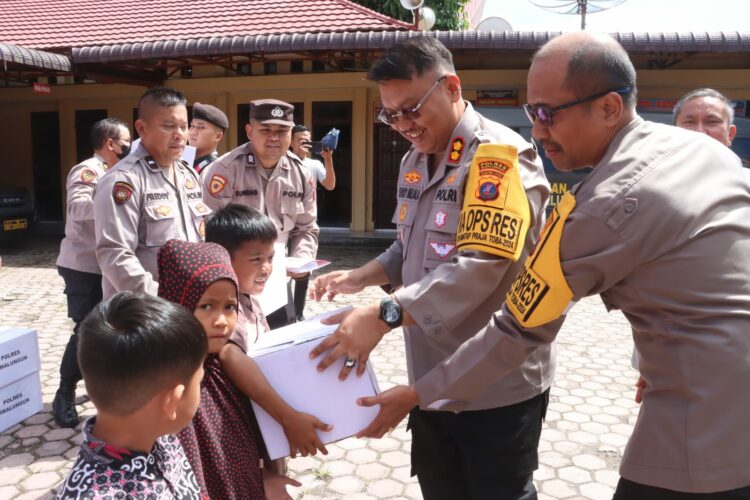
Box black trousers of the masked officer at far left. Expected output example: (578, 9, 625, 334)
(57, 267, 102, 385)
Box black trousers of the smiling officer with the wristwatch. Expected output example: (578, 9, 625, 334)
(409, 390, 549, 500)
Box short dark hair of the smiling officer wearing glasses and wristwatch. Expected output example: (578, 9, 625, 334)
(367, 36, 456, 82)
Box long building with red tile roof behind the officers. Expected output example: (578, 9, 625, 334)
(0, 0, 750, 231)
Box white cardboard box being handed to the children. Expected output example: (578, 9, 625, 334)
(251, 314, 380, 460)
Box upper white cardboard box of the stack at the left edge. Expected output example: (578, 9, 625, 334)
(0, 327, 39, 387)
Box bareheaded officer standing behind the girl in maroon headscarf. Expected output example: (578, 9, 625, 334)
(94, 88, 211, 298)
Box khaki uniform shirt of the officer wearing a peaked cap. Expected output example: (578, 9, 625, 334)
(201, 142, 319, 258)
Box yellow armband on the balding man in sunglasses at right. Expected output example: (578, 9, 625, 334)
(505, 192, 576, 328)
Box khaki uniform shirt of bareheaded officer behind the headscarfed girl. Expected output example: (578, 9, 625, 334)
(94, 144, 211, 298)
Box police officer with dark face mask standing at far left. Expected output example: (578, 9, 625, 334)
(52, 118, 130, 427)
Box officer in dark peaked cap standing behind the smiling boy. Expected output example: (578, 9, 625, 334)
(201, 99, 319, 328)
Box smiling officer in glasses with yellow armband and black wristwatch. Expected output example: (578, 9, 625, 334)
(312, 37, 553, 500)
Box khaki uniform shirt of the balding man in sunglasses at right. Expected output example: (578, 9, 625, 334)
(416, 118, 750, 493)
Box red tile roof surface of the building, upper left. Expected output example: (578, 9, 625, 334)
(0, 0, 409, 49)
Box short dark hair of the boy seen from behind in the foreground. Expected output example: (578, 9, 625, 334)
(78, 292, 208, 416)
